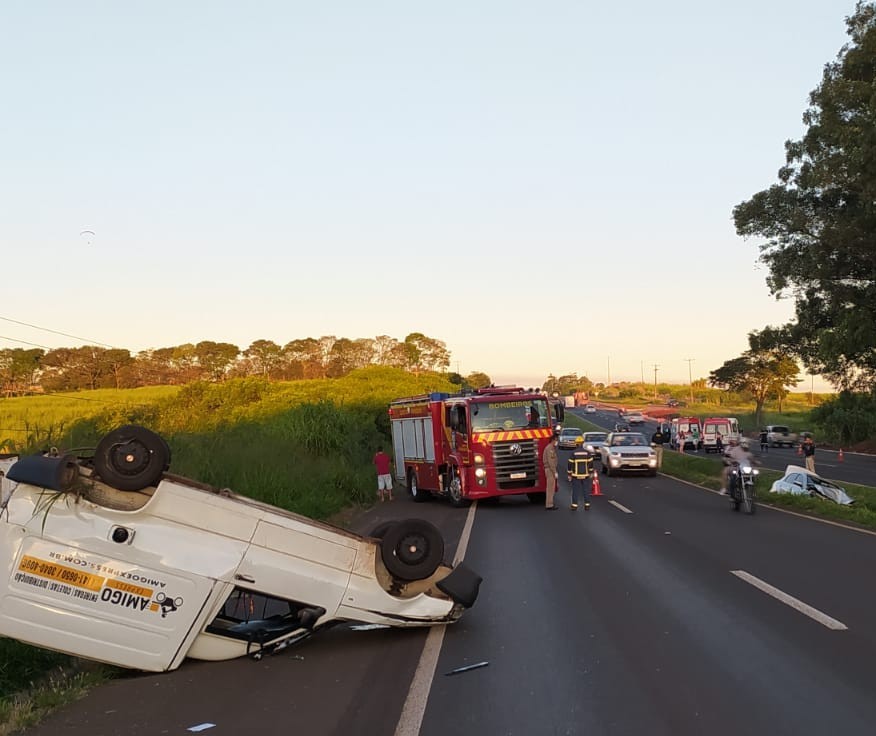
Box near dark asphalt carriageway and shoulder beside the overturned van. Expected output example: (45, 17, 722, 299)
(20, 466, 876, 736)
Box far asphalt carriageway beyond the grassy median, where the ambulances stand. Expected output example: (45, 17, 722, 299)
(566, 409, 876, 486)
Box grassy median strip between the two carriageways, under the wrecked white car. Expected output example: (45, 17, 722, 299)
(566, 414, 876, 529)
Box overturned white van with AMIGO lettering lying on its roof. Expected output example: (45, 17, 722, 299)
(0, 425, 481, 671)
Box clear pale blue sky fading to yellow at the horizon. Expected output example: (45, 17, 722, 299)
(0, 0, 854, 390)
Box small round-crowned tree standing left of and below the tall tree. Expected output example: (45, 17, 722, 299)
(709, 334, 800, 426)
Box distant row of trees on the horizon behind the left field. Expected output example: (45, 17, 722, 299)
(0, 332, 452, 397)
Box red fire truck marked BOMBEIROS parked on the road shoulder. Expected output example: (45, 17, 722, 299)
(389, 386, 562, 506)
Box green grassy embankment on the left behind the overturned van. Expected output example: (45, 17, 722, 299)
(0, 368, 455, 736)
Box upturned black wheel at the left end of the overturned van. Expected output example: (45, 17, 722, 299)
(94, 424, 170, 491)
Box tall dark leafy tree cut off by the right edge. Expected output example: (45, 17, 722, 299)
(733, 1, 876, 389)
